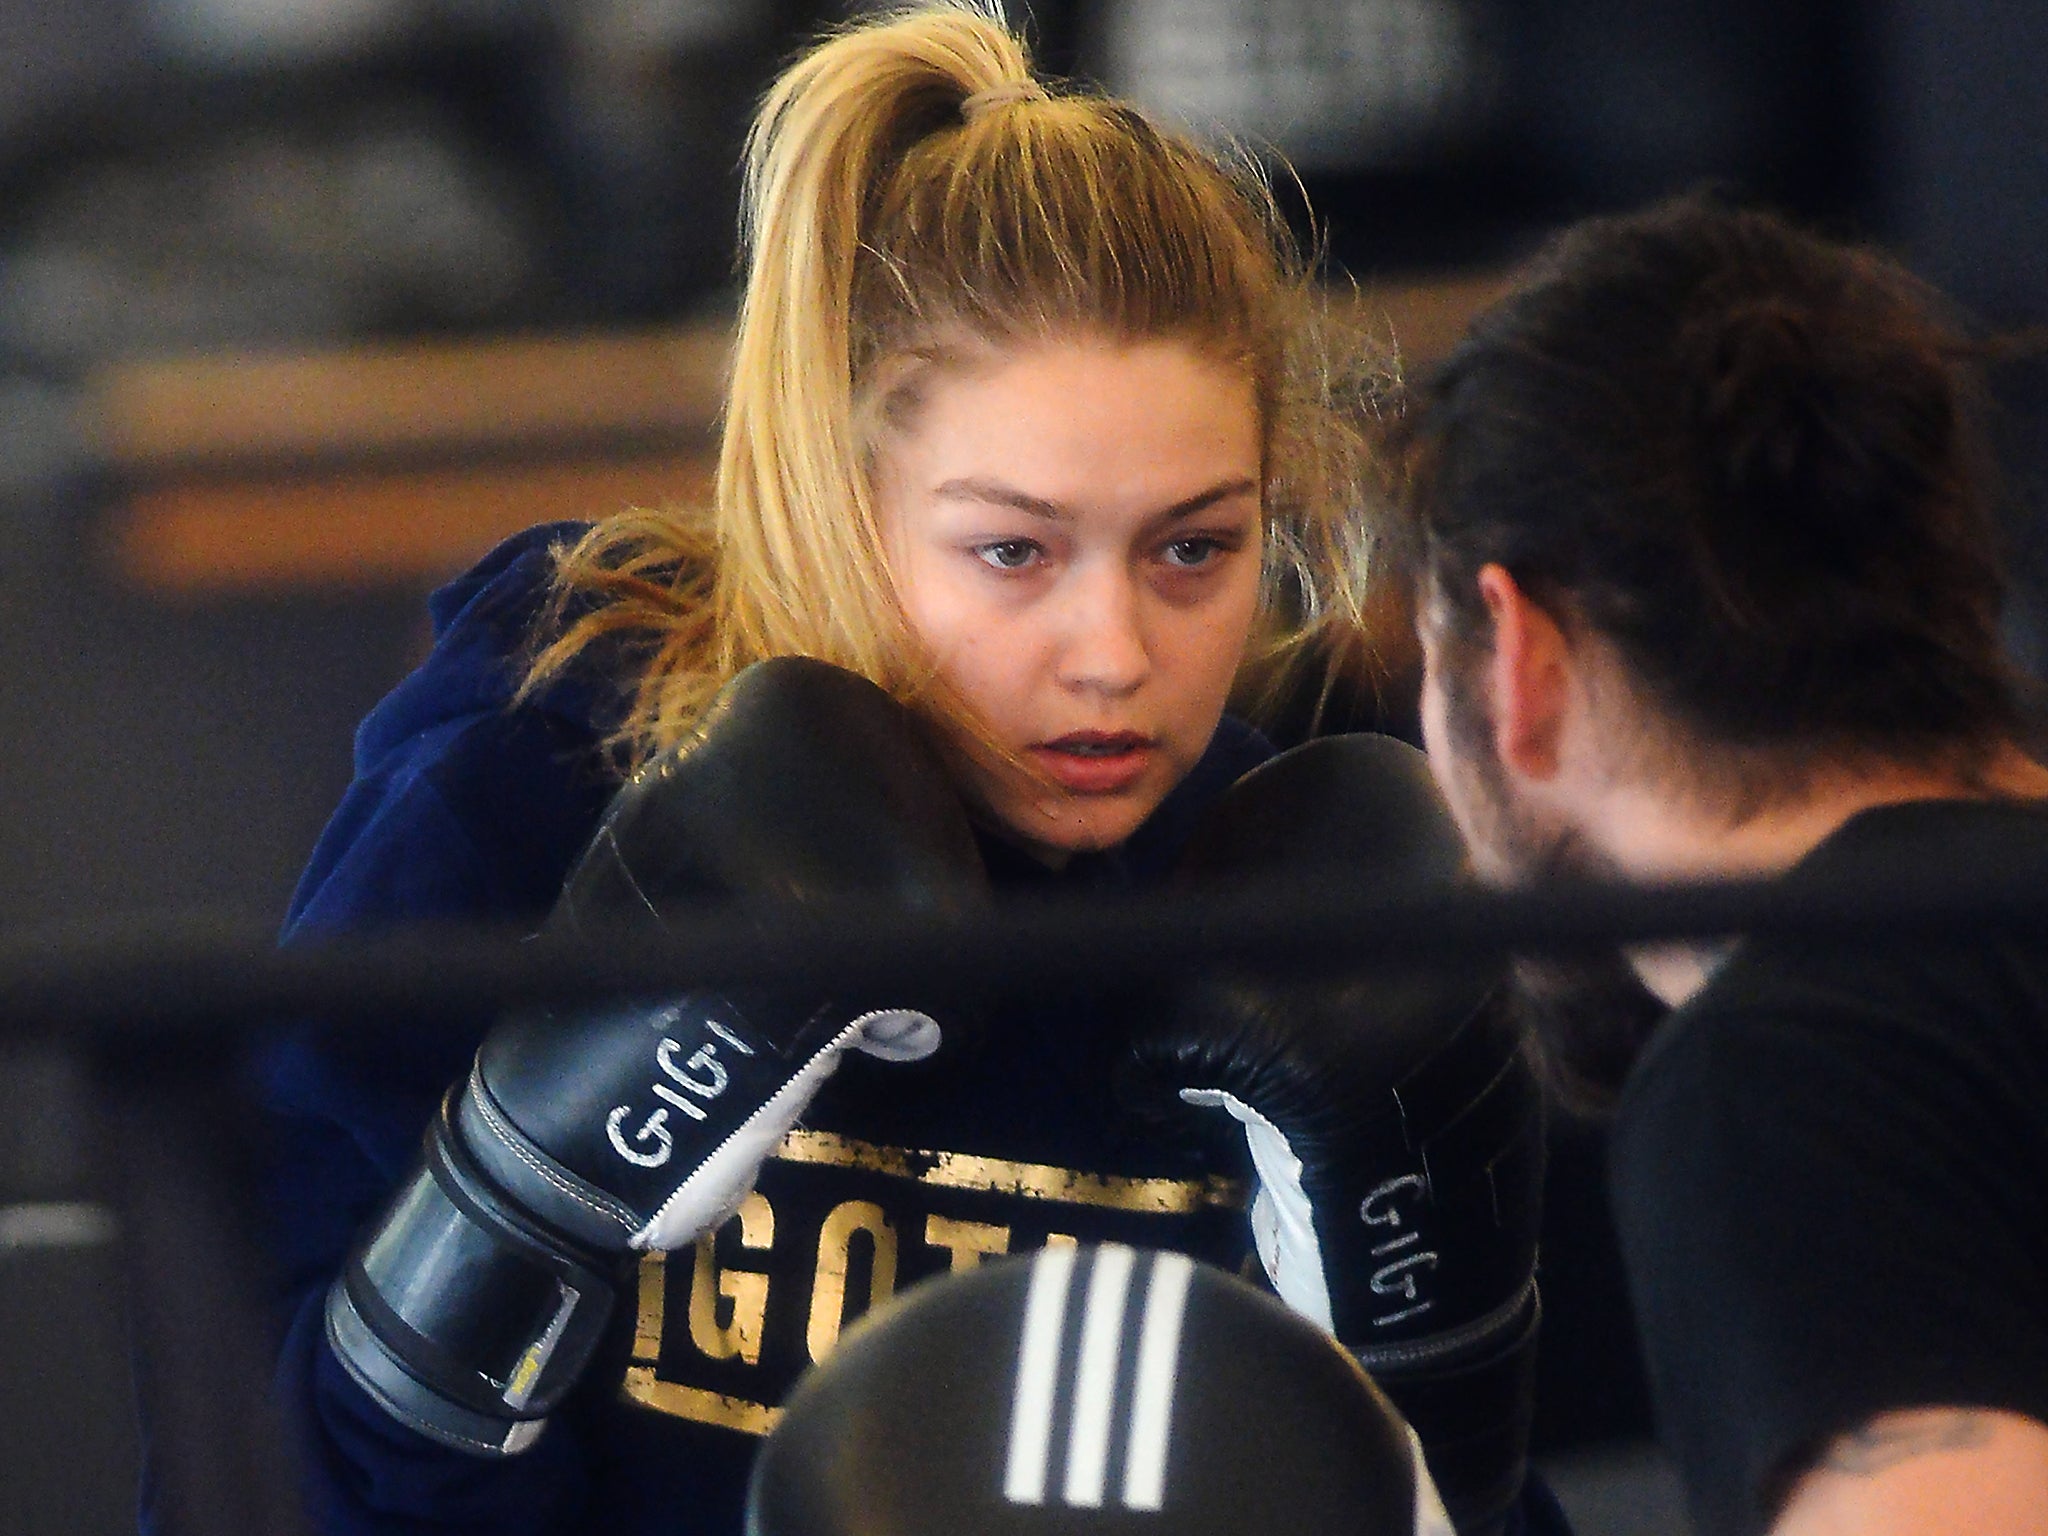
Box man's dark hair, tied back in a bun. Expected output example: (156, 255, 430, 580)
(1407, 197, 2017, 750)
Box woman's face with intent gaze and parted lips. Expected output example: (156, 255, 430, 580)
(877, 336, 1264, 862)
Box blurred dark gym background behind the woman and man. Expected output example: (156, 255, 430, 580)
(0, 0, 2048, 1536)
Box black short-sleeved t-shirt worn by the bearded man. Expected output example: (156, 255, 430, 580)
(1614, 801, 2048, 1536)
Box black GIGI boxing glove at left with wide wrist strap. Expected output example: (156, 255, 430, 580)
(328, 657, 983, 1454)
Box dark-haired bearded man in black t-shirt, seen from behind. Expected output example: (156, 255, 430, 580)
(1403, 199, 2048, 1536)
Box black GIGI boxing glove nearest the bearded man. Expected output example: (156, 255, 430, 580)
(1135, 735, 1544, 1534)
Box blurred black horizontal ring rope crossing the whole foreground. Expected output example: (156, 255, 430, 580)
(0, 852, 2048, 1044)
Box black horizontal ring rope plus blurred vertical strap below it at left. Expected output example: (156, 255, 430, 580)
(16, 852, 2048, 1536)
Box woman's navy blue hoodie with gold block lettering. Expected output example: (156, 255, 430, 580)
(260, 524, 1272, 1536)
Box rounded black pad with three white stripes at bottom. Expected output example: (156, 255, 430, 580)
(745, 1243, 1452, 1536)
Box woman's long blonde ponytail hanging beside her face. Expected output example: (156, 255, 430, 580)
(719, 8, 1030, 690)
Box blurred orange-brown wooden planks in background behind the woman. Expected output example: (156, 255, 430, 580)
(86, 272, 1507, 598)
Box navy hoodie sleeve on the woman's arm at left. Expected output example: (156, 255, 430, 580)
(256, 707, 608, 1536)
